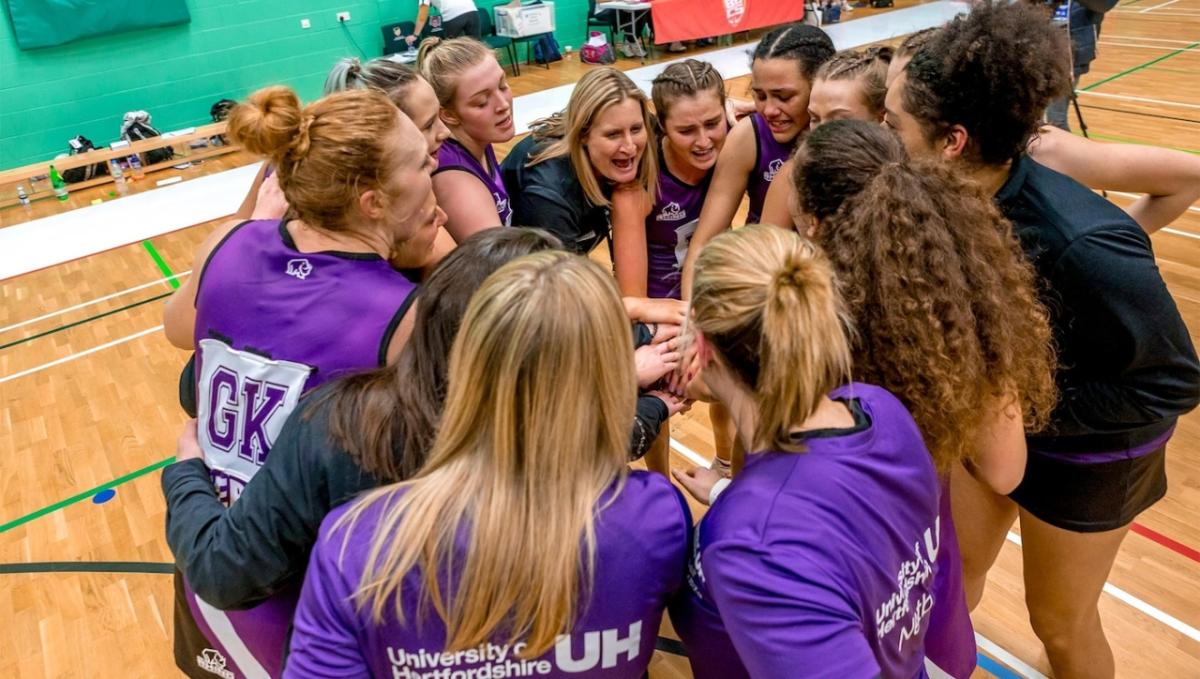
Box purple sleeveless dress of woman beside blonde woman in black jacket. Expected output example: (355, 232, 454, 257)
(646, 155, 713, 300)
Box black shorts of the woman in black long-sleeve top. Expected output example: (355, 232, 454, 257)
(1009, 444, 1166, 533)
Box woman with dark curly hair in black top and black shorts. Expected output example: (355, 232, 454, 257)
(886, 5, 1200, 678)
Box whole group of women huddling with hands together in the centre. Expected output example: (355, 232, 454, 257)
(162, 4, 1200, 679)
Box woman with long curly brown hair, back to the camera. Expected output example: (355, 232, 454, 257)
(791, 120, 1055, 677)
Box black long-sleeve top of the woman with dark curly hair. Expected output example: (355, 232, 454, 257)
(996, 156, 1200, 453)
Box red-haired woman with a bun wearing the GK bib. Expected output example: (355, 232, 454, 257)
(163, 86, 445, 677)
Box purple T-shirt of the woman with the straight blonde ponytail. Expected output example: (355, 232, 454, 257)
(671, 384, 974, 679)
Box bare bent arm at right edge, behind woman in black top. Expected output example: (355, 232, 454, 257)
(1028, 127, 1200, 233)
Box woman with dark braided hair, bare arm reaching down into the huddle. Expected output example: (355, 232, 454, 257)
(680, 24, 835, 298)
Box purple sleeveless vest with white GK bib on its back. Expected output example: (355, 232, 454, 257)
(176, 220, 416, 677)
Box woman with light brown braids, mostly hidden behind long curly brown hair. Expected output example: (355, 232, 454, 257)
(762, 47, 893, 227)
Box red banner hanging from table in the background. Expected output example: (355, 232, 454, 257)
(650, 0, 804, 44)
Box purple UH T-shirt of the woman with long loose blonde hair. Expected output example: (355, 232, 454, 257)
(286, 471, 691, 679)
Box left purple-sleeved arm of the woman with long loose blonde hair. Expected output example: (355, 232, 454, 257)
(283, 524, 372, 679)
